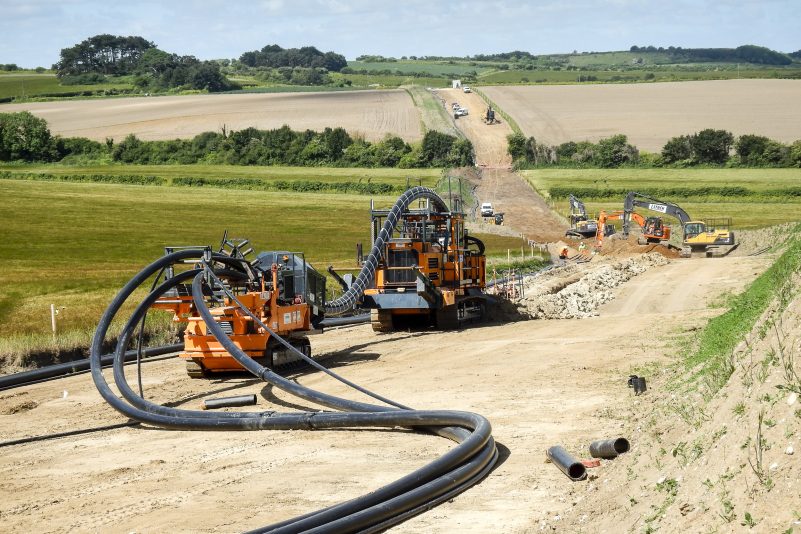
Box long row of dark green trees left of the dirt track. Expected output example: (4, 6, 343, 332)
(0, 111, 474, 168)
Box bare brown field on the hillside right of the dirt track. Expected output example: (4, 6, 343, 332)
(482, 80, 801, 152)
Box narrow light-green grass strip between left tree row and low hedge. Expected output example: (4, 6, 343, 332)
(0, 164, 442, 187)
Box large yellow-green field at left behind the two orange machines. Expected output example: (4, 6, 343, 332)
(0, 177, 520, 363)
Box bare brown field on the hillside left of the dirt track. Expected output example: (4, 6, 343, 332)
(0, 90, 422, 141)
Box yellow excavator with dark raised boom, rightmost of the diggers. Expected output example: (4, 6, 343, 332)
(596, 191, 738, 257)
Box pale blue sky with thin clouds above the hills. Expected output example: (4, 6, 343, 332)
(0, 0, 801, 68)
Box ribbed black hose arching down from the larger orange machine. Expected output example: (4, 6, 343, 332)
(325, 186, 448, 315)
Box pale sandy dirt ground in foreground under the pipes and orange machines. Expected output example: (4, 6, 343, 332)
(0, 257, 769, 533)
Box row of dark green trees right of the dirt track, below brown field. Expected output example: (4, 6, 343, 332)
(507, 129, 801, 168)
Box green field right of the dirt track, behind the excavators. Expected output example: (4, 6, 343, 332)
(521, 169, 801, 228)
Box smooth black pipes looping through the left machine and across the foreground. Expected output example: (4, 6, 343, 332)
(90, 249, 497, 532)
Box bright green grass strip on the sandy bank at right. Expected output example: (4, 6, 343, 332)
(684, 224, 801, 394)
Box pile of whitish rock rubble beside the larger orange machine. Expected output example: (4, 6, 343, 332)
(504, 253, 670, 319)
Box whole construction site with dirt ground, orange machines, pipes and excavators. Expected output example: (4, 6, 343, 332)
(0, 79, 801, 533)
